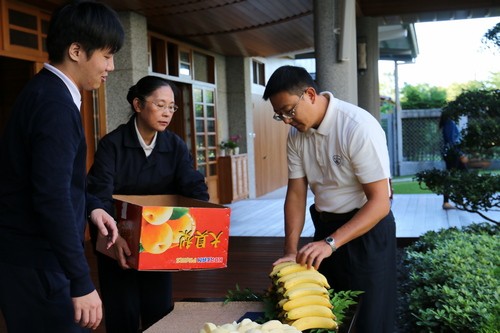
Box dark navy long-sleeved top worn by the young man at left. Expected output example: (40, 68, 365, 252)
(0, 69, 95, 297)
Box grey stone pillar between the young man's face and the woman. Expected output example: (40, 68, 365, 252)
(105, 12, 148, 132)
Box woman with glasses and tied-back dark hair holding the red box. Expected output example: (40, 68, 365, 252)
(88, 76, 209, 333)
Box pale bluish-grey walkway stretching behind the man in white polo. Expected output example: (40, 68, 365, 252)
(228, 188, 500, 238)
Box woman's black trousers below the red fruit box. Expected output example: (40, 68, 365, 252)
(97, 253, 173, 333)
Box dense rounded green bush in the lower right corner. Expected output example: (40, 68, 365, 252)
(403, 224, 500, 333)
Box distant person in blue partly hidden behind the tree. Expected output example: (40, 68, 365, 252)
(439, 113, 468, 210)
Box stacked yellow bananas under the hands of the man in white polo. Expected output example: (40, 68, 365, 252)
(269, 261, 337, 331)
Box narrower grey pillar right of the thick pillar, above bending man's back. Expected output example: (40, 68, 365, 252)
(357, 17, 380, 120)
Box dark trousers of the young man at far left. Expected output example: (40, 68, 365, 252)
(0, 262, 90, 333)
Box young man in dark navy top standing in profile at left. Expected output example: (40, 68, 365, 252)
(0, 1, 124, 333)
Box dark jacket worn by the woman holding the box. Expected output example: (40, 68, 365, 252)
(88, 117, 209, 226)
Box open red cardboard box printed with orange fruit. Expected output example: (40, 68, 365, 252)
(97, 195, 231, 271)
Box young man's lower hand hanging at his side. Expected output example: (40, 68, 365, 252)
(72, 290, 102, 330)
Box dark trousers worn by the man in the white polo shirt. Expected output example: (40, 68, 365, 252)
(309, 205, 396, 333)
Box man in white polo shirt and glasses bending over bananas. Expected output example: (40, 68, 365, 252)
(263, 66, 396, 333)
